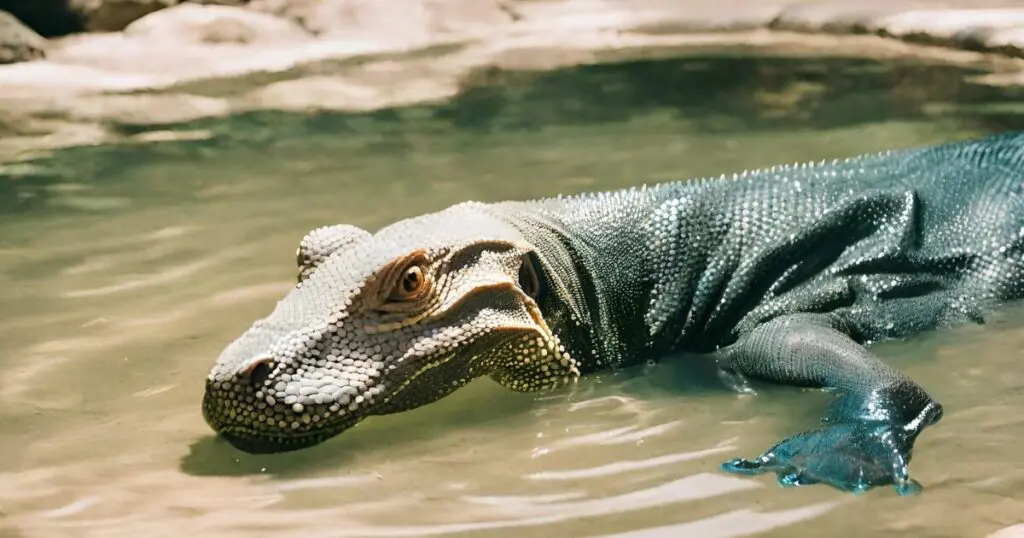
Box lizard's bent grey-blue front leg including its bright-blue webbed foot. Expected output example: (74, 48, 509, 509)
(717, 315, 942, 495)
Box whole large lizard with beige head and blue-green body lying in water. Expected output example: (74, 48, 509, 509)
(203, 133, 1024, 494)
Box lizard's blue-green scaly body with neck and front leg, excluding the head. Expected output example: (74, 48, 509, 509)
(498, 133, 1024, 493)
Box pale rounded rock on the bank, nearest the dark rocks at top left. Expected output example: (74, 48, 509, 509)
(125, 3, 311, 44)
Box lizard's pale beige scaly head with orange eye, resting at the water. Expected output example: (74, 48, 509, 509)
(203, 204, 579, 453)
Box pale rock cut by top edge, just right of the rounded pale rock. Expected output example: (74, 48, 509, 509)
(248, 0, 515, 47)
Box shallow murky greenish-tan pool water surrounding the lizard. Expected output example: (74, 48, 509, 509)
(0, 52, 1024, 538)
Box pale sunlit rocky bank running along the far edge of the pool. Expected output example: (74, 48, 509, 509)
(0, 0, 1024, 160)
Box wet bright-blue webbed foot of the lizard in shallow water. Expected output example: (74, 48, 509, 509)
(722, 421, 922, 495)
